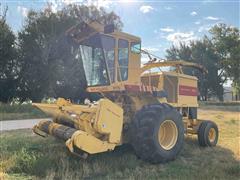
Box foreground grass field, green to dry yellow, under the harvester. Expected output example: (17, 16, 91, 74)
(0, 108, 240, 180)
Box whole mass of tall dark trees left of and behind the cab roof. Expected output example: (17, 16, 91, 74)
(0, 5, 123, 102)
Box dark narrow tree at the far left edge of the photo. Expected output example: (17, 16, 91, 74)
(0, 9, 19, 102)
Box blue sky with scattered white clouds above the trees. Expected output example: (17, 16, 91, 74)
(0, 0, 240, 57)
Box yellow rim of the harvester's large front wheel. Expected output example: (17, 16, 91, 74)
(158, 120, 178, 150)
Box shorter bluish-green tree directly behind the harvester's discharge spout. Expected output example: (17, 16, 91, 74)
(166, 36, 226, 100)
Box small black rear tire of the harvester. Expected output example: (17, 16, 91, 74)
(198, 121, 218, 147)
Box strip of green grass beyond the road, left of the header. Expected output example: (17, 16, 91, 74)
(0, 104, 47, 121)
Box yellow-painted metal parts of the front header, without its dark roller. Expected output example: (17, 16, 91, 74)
(33, 99, 123, 154)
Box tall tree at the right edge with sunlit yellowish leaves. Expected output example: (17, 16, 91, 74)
(210, 24, 240, 100)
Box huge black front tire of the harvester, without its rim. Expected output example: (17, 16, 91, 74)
(131, 104, 184, 163)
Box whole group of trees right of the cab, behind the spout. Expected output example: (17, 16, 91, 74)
(166, 24, 240, 101)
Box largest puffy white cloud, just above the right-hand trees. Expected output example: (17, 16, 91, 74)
(166, 31, 198, 46)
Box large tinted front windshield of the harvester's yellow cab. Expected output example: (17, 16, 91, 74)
(78, 34, 115, 86)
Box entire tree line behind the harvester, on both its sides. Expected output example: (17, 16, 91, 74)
(0, 5, 240, 102)
